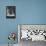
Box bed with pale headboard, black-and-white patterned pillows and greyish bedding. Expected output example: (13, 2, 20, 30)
(18, 24, 46, 46)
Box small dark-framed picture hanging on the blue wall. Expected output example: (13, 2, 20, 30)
(6, 6, 16, 18)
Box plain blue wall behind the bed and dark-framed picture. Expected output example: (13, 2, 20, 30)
(0, 0, 46, 43)
